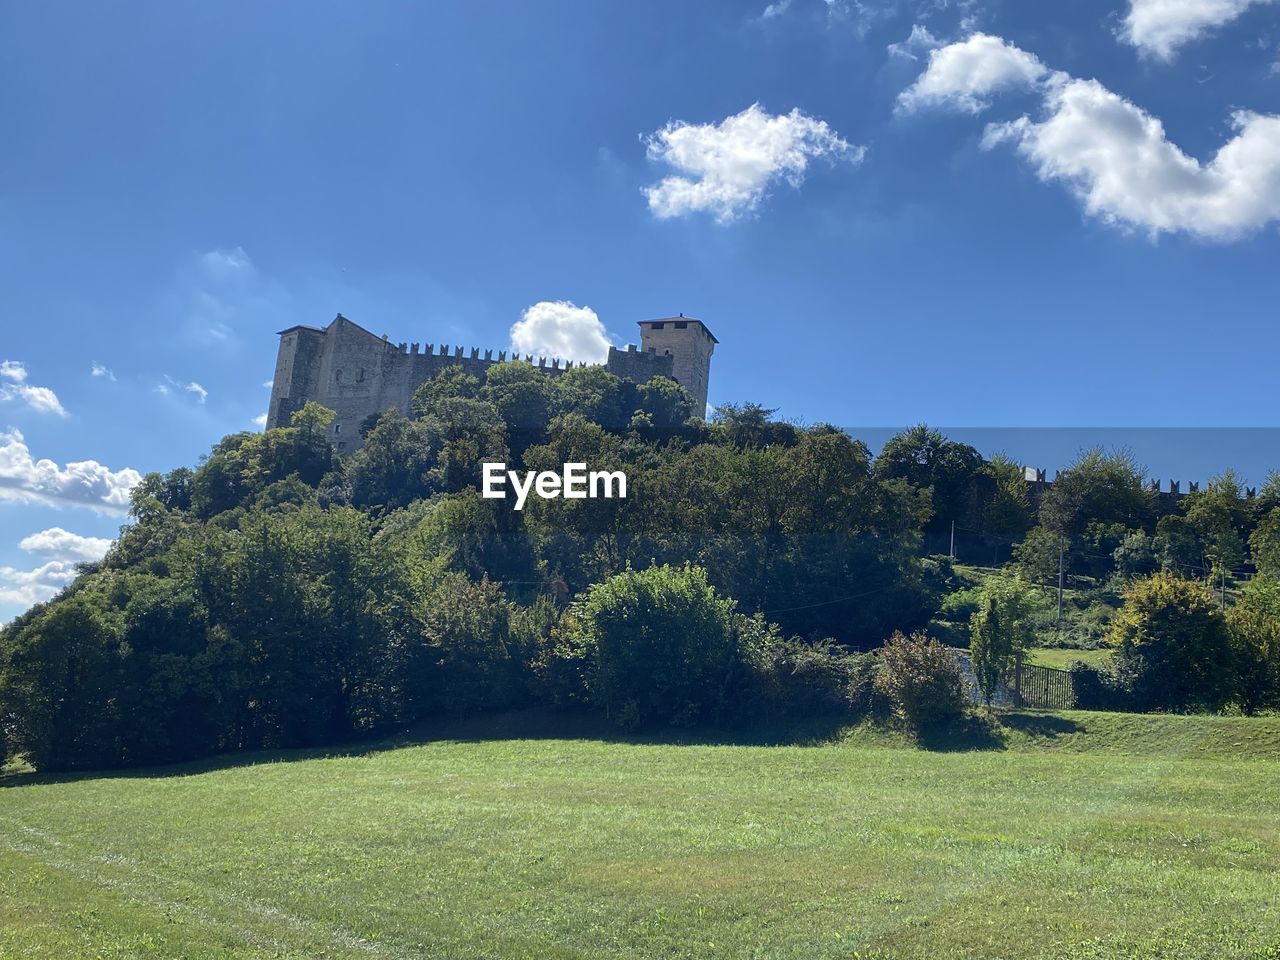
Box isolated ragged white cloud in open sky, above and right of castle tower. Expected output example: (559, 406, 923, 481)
(643, 104, 865, 223)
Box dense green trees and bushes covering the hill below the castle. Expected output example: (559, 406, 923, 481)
(0, 364, 1280, 771)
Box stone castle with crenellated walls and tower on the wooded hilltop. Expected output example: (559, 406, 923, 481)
(266, 314, 718, 453)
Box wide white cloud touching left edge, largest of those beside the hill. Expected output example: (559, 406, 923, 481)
(0, 430, 142, 513)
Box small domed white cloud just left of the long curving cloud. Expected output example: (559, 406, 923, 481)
(897, 33, 1048, 114)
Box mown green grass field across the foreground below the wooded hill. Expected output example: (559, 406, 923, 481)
(0, 712, 1280, 960)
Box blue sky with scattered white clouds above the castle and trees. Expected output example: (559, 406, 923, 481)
(0, 0, 1280, 622)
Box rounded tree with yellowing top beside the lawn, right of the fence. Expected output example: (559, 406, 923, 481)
(1110, 573, 1234, 710)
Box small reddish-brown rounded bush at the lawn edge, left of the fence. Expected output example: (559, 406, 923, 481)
(876, 634, 966, 733)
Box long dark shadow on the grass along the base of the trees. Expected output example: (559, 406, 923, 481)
(0, 709, 855, 788)
